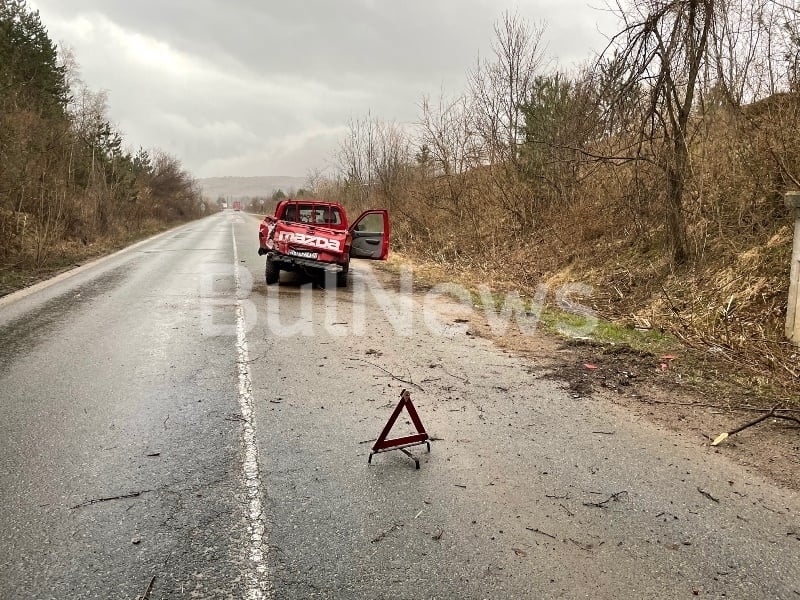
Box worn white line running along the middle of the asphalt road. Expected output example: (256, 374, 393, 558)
(231, 224, 272, 600)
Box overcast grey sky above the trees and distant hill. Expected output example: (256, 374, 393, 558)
(29, 0, 615, 177)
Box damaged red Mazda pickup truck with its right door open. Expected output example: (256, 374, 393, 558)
(258, 200, 389, 287)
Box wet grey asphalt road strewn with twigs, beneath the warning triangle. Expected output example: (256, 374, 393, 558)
(0, 213, 800, 600)
